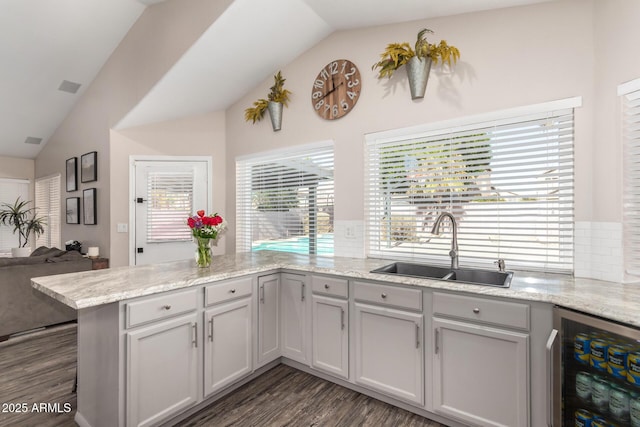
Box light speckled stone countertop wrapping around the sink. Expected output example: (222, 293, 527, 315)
(32, 251, 640, 327)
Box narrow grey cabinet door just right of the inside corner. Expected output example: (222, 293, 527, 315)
(280, 273, 307, 363)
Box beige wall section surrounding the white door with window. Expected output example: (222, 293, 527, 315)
(110, 112, 227, 266)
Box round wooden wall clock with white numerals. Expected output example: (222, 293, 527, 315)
(311, 59, 362, 120)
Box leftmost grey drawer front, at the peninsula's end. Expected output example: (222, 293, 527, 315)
(125, 289, 198, 328)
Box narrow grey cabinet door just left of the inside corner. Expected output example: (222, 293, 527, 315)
(258, 274, 280, 367)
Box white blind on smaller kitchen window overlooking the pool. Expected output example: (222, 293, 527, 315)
(236, 146, 333, 256)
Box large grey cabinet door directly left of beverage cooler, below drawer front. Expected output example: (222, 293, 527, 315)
(433, 318, 529, 426)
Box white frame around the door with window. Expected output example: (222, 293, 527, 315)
(129, 155, 213, 266)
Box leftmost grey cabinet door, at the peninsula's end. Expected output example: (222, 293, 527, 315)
(124, 313, 195, 426)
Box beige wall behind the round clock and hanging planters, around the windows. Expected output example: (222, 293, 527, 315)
(227, 0, 596, 253)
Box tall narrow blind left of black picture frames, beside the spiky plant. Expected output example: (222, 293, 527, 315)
(35, 175, 64, 249)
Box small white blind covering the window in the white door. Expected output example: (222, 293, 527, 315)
(147, 170, 195, 243)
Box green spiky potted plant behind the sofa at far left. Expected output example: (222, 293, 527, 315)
(0, 197, 45, 257)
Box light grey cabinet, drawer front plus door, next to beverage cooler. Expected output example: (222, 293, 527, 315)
(432, 293, 530, 427)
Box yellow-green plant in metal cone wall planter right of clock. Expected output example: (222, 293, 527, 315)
(371, 28, 460, 99)
